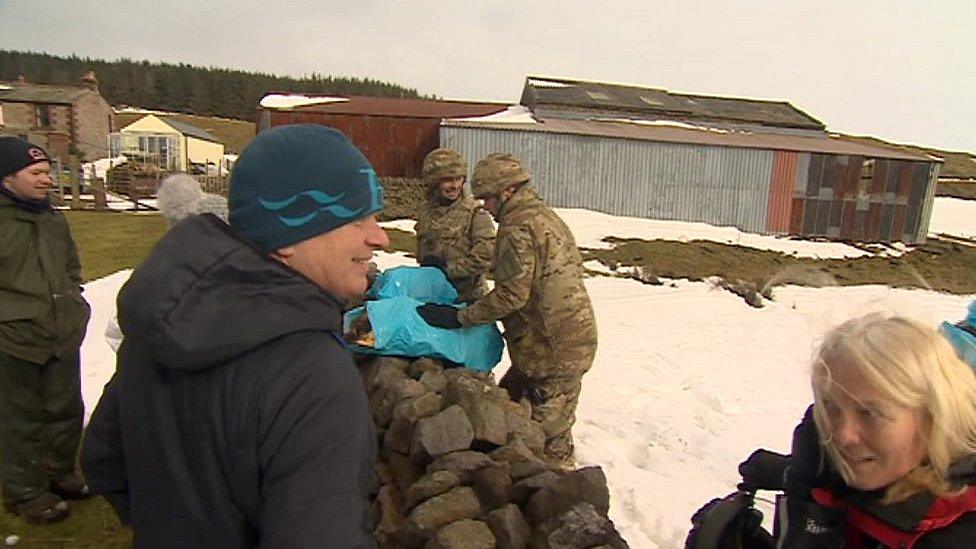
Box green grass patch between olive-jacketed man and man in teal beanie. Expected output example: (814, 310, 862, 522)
(65, 211, 166, 281)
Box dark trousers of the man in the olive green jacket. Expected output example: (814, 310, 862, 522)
(0, 350, 85, 503)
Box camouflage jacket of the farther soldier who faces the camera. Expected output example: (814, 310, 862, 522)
(417, 193, 495, 302)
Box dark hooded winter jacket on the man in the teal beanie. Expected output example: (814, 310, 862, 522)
(82, 215, 375, 549)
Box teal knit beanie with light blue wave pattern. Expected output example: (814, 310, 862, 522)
(228, 124, 383, 252)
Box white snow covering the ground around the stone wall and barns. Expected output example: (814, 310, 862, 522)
(82, 198, 976, 549)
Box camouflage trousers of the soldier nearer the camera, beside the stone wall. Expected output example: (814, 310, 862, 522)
(498, 347, 596, 468)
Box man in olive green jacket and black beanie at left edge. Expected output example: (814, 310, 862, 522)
(0, 137, 91, 523)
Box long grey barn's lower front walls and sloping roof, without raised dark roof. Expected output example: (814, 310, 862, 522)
(440, 119, 939, 243)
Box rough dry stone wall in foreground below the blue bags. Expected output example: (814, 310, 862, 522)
(361, 357, 627, 549)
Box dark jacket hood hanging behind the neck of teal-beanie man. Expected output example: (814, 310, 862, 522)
(118, 214, 341, 369)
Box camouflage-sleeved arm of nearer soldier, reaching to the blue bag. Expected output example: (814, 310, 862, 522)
(458, 227, 537, 326)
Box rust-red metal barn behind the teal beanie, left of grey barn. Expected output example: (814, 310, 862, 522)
(258, 96, 507, 177)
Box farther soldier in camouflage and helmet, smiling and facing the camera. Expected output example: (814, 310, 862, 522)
(417, 148, 495, 302)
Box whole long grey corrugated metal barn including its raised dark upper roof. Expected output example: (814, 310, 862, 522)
(441, 76, 940, 243)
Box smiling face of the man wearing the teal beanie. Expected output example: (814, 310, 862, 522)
(275, 215, 390, 301)
